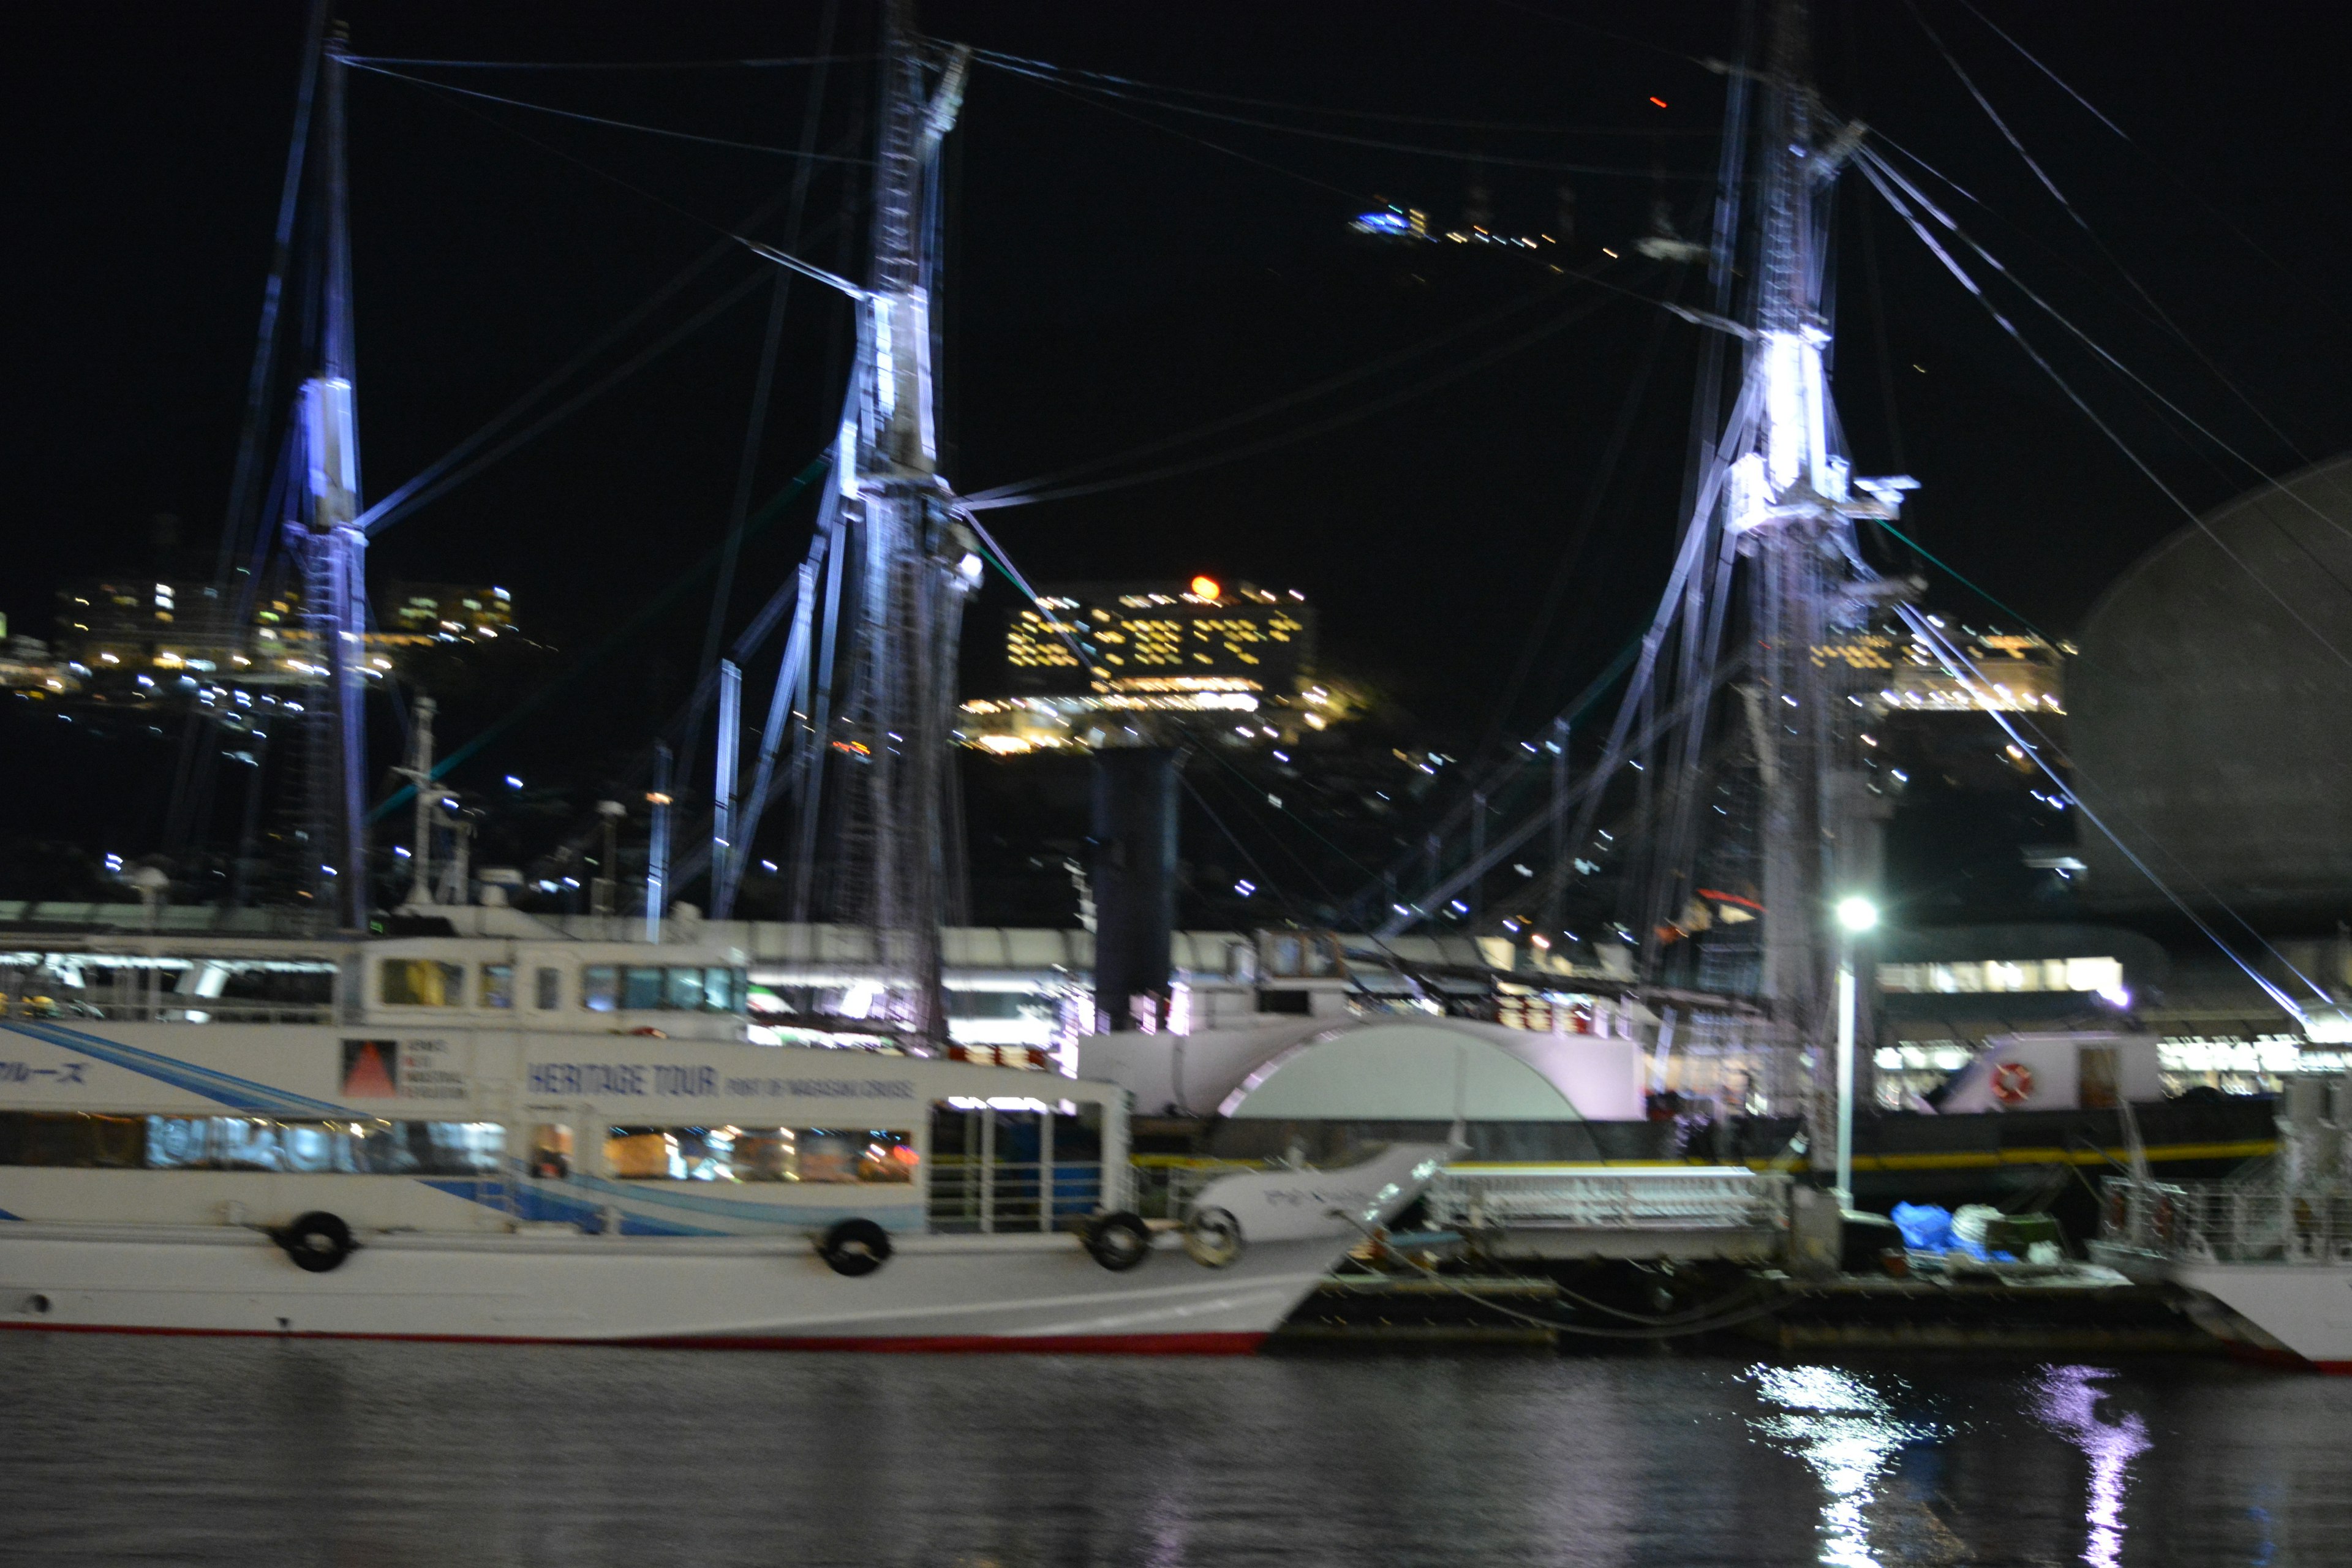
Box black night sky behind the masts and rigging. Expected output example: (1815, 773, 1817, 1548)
(0, 0, 2352, 879)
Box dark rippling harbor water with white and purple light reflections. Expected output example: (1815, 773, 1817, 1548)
(0, 1333, 2352, 1568)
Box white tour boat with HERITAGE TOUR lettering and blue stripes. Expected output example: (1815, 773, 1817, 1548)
(0, 936, 1444, 1352)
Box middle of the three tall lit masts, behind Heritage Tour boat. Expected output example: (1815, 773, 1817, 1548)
(780, 0, 981, 1046)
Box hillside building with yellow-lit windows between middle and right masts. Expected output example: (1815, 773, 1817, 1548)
(957, 576, 1362, 755)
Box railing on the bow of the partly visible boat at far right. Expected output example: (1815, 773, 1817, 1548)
(2098, 1175, 2352, 1262)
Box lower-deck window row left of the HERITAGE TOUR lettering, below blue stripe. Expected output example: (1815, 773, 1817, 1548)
(0, 1112, 506, 1175)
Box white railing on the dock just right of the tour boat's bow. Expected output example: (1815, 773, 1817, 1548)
(1428, 1166, 1790, 1229)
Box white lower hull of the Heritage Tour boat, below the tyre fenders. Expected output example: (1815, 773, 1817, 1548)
(0, 1225, 1348, 1352)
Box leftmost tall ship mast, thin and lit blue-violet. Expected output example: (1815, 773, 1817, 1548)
(289, 33, 369, 931)
